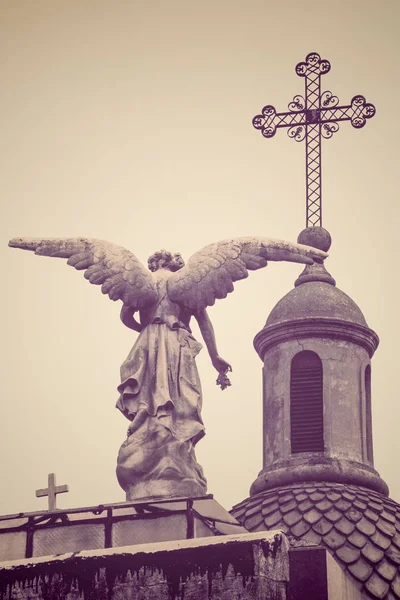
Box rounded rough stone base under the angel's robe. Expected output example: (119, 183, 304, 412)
(117, 421, 207, 500)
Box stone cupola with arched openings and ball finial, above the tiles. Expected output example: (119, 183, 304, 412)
(251, 228, 388, 495)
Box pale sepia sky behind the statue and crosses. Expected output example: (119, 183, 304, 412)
(0, 0, 400, 514)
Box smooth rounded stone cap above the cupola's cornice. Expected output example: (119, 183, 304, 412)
(266, 276, 367, 327)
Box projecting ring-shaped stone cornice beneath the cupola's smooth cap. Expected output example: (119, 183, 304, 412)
(254, 317, 379, 361)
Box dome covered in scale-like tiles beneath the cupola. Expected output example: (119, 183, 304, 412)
(231, 483, 400, 600)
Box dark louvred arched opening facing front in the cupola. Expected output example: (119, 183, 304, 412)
(290, 350, 324, 453)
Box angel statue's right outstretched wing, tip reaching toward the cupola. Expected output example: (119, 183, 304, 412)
(168, 237, 327, 310)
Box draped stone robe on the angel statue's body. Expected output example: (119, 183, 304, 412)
(117, 270, 204, 445)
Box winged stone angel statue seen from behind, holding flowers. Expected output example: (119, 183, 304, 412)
(9, 237, 326, 500)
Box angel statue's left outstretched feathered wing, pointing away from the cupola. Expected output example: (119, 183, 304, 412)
(8, 238, 157, 309)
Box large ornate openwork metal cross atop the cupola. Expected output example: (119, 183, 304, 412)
(253, 52, 376, 227)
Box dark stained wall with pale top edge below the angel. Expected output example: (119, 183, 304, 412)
(0, 532, 289, 600)
